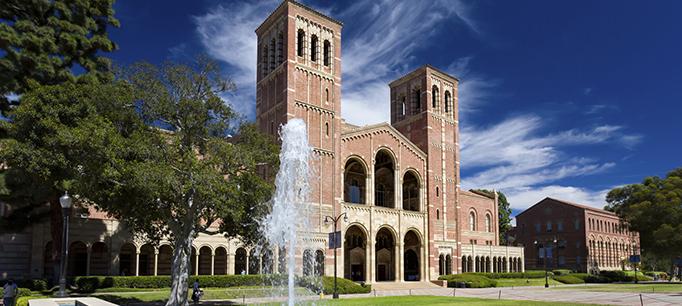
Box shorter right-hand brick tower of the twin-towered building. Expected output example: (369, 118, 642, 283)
(389, 65, 461, 275)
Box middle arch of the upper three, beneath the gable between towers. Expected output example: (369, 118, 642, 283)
(374, 149, 395, 208)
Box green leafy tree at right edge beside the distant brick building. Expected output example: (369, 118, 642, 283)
(606, 168, 682, 272)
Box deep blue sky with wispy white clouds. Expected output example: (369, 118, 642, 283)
(111, 0, 682, 213)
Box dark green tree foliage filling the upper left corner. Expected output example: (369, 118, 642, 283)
(0, 0, 119, 114)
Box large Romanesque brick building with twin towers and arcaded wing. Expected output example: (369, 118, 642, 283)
(0, 0, 524, 283)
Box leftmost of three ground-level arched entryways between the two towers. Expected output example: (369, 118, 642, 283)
(343, 225, 367, 282)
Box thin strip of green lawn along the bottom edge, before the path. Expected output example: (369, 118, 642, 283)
(272, 295, 596, 306)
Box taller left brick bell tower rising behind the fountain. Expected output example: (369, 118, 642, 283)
(256, 0, 342, 237)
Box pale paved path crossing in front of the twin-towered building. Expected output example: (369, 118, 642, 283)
(216, 285, 682, 306)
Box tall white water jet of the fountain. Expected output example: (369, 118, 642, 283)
(261, 119, 312, 305)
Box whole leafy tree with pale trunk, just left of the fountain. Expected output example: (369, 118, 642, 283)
(78, 59, 278, 305)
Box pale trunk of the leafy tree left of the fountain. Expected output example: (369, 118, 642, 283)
(166, 224, 194, 306)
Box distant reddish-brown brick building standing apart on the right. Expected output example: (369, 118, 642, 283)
(514, 198, 639, 272)
